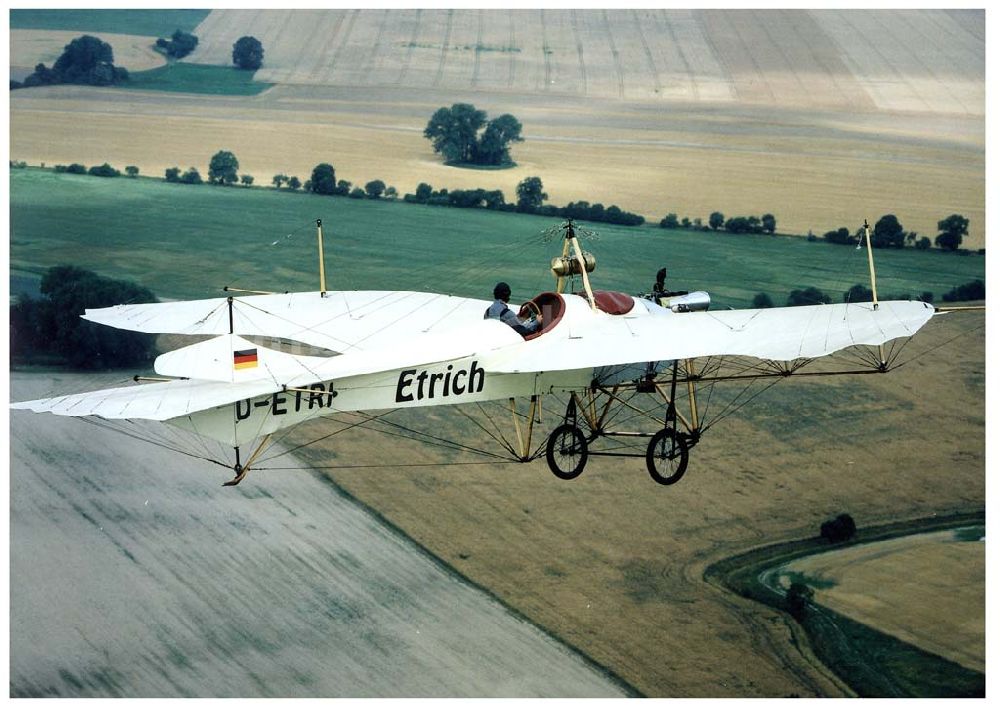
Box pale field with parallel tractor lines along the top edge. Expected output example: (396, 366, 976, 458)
(182, 9, 985, 116)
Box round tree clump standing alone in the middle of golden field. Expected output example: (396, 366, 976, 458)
(424, 103, 524, 167)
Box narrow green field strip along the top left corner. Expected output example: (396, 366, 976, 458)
(10, 8, 211, 37)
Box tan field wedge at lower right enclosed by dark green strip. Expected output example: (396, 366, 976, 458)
(781, 531, 986, 674)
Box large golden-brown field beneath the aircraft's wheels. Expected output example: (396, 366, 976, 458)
(288, 313, 986, 696)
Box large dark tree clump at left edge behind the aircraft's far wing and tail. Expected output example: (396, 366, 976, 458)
(10, 265, 156, 369)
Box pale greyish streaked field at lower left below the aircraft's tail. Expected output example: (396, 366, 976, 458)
(10, 373, 626, 697)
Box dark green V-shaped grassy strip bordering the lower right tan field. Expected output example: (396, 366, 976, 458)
(703, 510, 986, 697)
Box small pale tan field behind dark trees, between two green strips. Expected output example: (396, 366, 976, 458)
(10, 30, 167, 80)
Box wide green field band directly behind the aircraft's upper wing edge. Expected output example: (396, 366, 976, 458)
(10, 171, 985, 307)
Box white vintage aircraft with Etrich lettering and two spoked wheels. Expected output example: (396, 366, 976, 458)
(11, 222, 935, 485)
